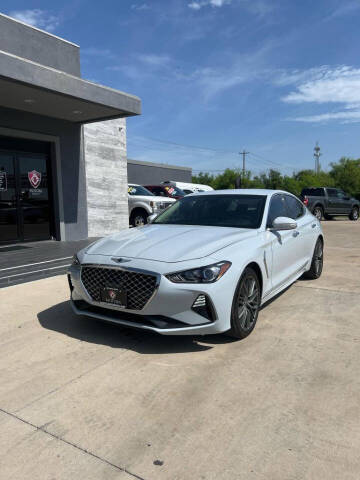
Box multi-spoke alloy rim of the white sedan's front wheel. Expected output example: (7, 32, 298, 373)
(237, 275, 260, 330)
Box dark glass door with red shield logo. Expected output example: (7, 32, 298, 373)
(16, 154, 50, 240)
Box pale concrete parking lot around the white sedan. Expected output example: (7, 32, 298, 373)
(0, 219, 360, 480)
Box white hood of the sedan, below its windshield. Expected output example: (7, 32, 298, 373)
(86, 225, 257, 263)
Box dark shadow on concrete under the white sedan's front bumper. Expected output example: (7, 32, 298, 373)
(38, 301, 233, 354)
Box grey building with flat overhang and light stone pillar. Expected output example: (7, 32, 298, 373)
(0, 14, 141, 244)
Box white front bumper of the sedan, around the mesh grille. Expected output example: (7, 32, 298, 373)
(68, 257, 233, 335)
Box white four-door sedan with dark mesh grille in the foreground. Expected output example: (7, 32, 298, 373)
(69, 190, 324, 338)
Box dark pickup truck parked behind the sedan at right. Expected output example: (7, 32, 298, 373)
(300, 187, 360, 220)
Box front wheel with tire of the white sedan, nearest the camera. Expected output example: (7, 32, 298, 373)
(227, 267, 261, 338)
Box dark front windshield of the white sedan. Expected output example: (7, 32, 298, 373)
(153, 195, 266, 228)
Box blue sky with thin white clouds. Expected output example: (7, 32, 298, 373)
(1, 0, 360, 174)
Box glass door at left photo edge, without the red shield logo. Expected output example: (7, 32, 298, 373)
(0, 152, 19, 243)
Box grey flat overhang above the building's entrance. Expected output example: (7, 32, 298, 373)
(0, 50, 141, 123)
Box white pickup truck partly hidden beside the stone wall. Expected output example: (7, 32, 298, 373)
(128, 183, 176, 227)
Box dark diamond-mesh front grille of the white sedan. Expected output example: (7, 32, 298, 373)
(81, 267, 157, 310)
